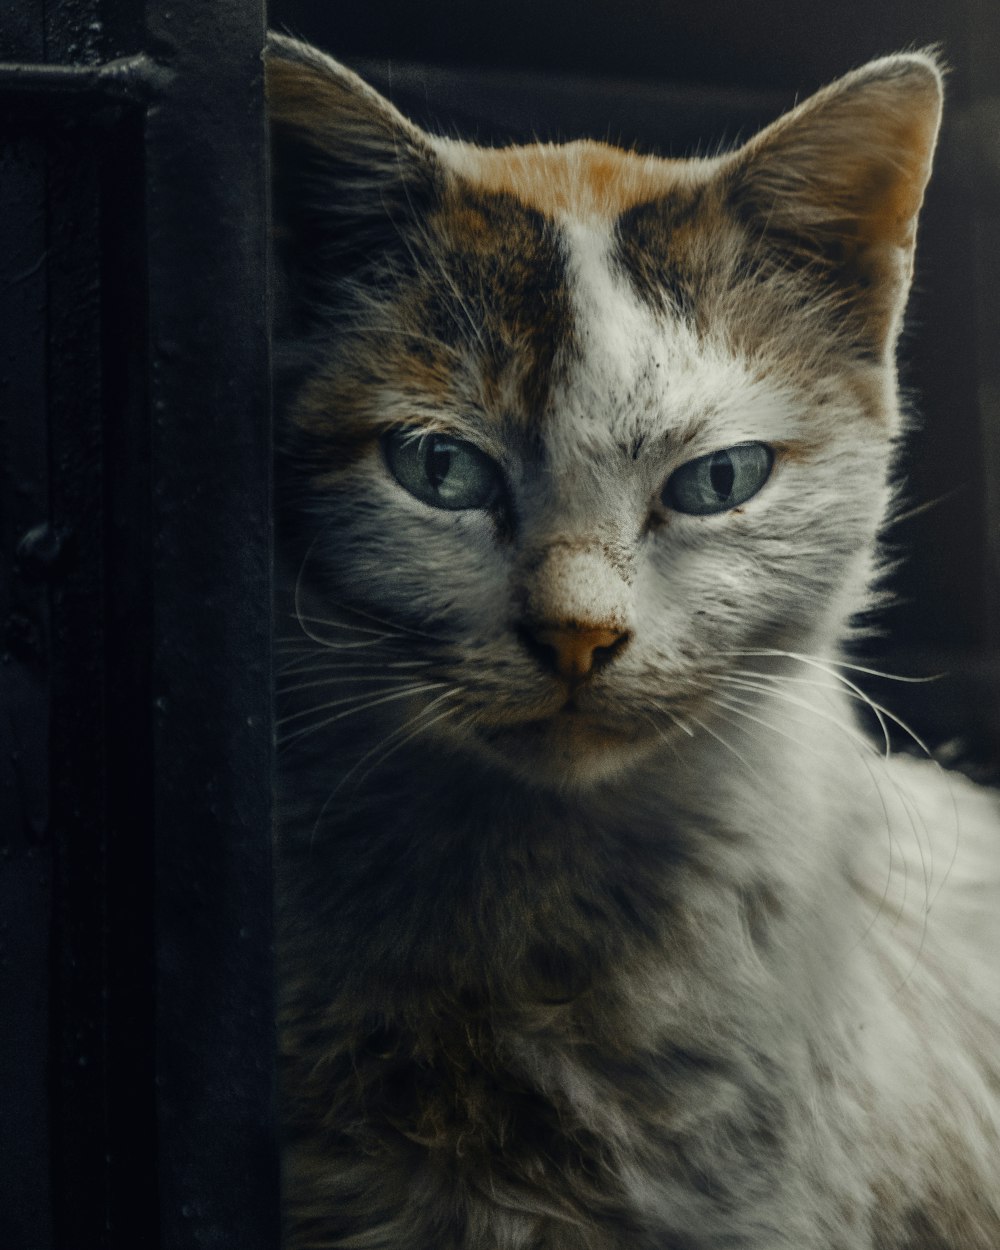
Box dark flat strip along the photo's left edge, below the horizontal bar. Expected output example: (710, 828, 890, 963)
(0, 124, 53, 1250)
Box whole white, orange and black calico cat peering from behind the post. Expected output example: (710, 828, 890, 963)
(268, 36, 1000, 1250)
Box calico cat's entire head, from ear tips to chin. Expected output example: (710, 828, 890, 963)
(269, 39, 941, 781)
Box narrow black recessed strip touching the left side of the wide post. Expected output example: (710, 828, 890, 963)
(99, 110, 159, 1250)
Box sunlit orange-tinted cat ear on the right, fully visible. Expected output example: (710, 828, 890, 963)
(726, 53, 943, 359)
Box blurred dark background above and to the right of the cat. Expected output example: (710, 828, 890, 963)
(270, 0, 1000, 774)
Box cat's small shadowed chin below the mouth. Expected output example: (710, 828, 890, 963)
(465, 713, 660, 789)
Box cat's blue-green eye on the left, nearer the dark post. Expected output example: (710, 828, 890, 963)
(383, 429, 503, 513)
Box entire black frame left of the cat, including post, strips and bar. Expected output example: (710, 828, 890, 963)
(0, 0, 278, 1250)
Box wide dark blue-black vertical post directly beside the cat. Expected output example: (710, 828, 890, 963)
(140, 0, 278, 1250)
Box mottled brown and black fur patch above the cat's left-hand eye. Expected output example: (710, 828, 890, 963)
(285, 181, 573, 483)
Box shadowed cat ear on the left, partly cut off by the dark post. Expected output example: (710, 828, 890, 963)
(266, 35, 441, 321)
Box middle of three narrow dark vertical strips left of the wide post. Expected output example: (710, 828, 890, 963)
(46, 119, 118, 1246)
